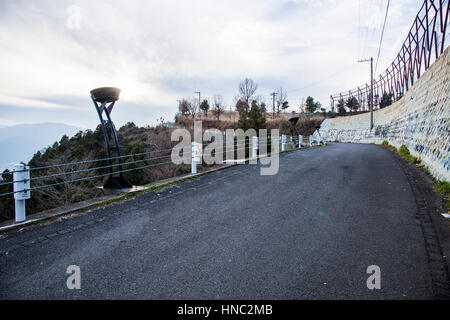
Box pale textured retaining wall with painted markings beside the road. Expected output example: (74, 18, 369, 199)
(320, 47, 450, 181)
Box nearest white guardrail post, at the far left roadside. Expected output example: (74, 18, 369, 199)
(13, 164, 30, 222)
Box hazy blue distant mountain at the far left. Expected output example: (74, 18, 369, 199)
(0, 123, 83, 171)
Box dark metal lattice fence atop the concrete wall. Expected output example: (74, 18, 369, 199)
(330, 0, 450, 112)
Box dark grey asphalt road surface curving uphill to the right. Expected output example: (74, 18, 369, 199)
(0, 144, 433, 299)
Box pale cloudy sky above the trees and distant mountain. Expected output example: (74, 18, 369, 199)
(0, 0, 422, 129)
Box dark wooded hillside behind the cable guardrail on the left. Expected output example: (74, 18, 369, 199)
(0, 123, 189, 221)
